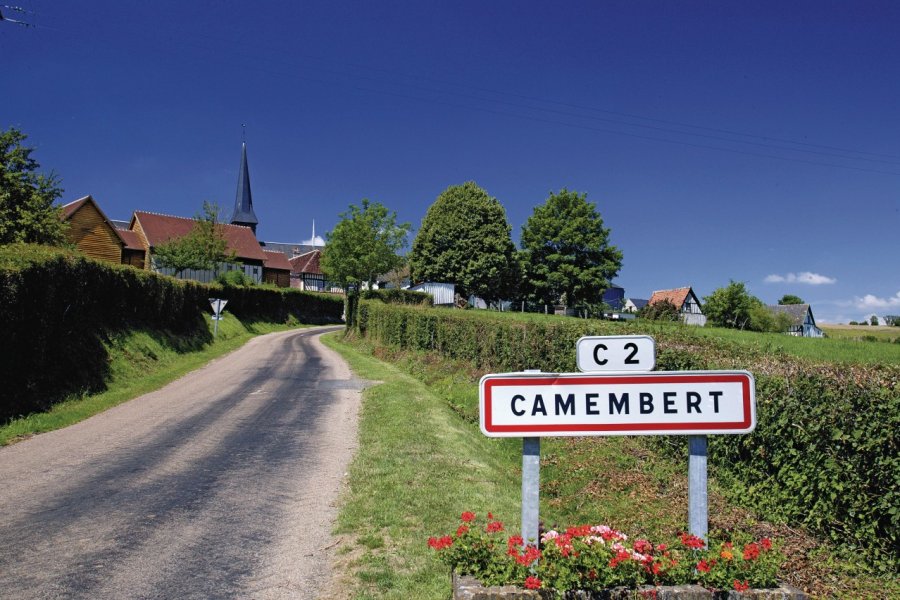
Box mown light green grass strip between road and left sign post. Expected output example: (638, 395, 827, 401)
(323, 334, 520, 600)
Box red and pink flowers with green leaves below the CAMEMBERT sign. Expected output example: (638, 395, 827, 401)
(428, 512, 783, 594)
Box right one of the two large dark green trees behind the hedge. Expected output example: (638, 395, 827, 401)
(520, 188, 622, 306)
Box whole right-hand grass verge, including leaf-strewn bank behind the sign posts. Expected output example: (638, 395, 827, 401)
(324, 334, 900, 599)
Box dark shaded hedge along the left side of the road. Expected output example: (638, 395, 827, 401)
(0, 244, 343, 421)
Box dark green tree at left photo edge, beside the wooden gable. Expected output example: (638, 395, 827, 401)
(0, 128, 68, 246)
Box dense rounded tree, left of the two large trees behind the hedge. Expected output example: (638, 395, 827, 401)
(409, 181, 518, 302)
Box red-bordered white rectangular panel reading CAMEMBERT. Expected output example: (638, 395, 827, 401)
(480, 371, 756, 437)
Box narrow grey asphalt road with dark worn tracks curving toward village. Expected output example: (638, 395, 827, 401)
(0, 329, 364, 599)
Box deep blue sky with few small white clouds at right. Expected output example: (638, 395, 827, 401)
(0, 0, 900, 322)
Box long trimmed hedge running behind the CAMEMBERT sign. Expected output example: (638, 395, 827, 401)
(356, 301, 900, 569)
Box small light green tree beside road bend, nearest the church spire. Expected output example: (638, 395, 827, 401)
(319, 199, 410, 289)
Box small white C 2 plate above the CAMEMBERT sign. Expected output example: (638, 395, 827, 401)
(575, 335, 656, 373)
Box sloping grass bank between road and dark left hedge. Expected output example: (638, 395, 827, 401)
(0, 314, 306, 446)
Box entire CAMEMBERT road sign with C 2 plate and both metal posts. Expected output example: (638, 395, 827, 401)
(479, 336, 756, 543)
